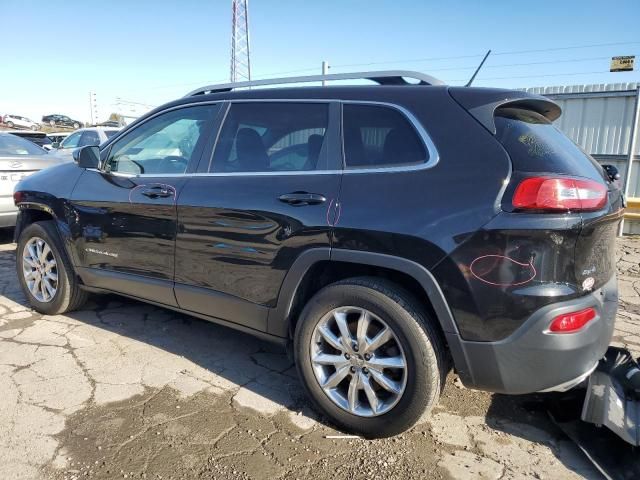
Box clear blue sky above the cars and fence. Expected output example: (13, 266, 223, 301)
(0, 0, 640, 121)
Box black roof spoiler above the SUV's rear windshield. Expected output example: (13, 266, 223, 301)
(449, 87, 562, 135)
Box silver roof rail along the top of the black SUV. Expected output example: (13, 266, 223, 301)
(185, 70, 444, 97)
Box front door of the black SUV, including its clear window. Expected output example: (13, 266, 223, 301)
(71, 104, 218, 305)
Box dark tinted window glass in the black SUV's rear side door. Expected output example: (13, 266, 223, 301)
(209, 102, 329, 172)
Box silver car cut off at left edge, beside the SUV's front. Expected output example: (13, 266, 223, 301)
(0, 132, 60, 227)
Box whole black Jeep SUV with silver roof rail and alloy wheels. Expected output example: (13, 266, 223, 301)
(15, 72, 622, 436)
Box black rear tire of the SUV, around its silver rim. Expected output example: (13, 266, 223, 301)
(294, 277, 447, 438)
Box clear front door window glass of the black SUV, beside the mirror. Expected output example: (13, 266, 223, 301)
(105, 105, 218, 174)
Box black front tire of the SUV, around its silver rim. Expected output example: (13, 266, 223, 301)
(16, 220, 88, 315)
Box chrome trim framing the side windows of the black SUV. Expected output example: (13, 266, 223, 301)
(88, 98, 440, 178)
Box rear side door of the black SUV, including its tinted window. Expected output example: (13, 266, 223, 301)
(175, 101, 341, 331)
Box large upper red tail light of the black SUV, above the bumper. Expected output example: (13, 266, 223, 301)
(512, 177, 607, 212)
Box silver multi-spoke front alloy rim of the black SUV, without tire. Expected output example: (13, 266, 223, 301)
(22, 237, 58, 303)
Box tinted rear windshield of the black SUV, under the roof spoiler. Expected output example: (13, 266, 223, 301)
(495, 108, 604, 181)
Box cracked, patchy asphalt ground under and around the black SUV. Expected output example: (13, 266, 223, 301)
(0, 233, 640, 480)
